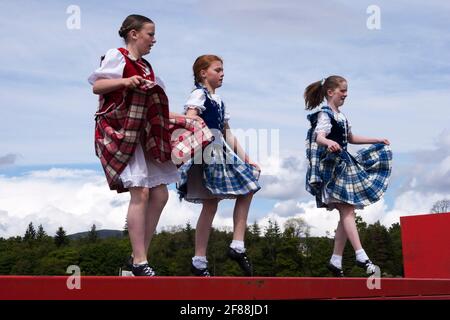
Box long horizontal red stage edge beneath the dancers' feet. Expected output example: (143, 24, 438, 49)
(0, 276, 450, 300)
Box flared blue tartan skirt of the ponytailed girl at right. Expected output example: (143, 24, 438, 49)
(319, 143, 392, 208)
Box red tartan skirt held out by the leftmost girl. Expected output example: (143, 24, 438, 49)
(95, 86, 213, 192)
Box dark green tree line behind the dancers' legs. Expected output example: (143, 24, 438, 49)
(0, 217, 403, 277)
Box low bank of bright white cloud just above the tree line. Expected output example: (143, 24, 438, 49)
(0, 160, 449, 237)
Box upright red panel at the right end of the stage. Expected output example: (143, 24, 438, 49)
(400, 213, 450, 279)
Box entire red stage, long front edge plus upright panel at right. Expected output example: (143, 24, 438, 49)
(0, 213, 450, 300)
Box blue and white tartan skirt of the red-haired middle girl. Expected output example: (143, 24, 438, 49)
(177, 138, 261, 203)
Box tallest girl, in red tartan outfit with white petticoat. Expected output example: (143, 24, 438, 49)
(89, 15, 202, 276)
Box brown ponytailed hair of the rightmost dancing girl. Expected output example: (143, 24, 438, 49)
(303, 76, 347, 110)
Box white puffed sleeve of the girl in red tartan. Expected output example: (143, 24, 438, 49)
(88, 49, 125, 85)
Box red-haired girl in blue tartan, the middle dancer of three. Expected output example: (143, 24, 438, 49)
(177, 55, 260, 276)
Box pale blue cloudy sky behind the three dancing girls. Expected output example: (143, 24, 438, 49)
(0, 0, 450, 236)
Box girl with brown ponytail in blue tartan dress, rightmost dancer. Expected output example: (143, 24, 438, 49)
(304, 76, 392, 277)
